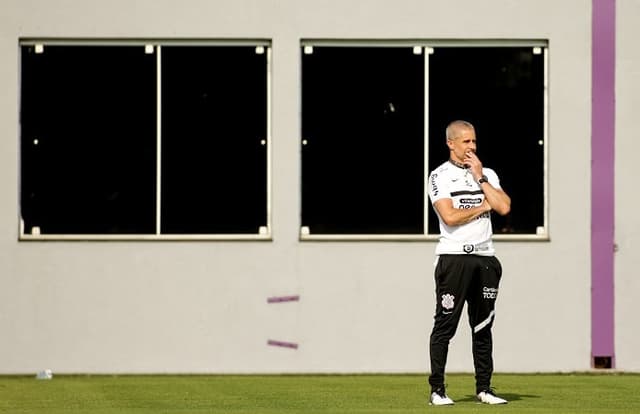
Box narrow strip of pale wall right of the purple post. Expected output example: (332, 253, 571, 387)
(615, 0, 640, 371)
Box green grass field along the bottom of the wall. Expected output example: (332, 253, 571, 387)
(0, 374, 640, 414)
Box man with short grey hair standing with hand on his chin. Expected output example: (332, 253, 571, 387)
(428, 121, 511, 405)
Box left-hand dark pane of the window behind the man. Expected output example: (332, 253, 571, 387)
(302, 47, 424, 234)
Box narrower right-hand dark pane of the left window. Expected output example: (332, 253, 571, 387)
(161, 46, 267, 234)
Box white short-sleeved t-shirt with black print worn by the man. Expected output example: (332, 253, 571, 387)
(428, 161, 501, 256)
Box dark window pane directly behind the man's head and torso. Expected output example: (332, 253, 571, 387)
(429, 47, 545, 234)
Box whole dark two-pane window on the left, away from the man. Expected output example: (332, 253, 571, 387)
(20, 44, 269, 238)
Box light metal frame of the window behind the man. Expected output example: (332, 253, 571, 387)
(299, 38, 550, 241)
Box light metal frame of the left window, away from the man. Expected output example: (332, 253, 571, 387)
(17, 38, 272, 241)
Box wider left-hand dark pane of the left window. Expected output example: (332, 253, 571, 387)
(21, 46, 156, 234)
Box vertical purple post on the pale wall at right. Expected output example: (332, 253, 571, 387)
(591, 0, 616, 368)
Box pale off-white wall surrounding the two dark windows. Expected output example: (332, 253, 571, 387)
(0, 0, 616, 373)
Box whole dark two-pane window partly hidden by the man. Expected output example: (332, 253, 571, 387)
(302, 42, 547, 238)
